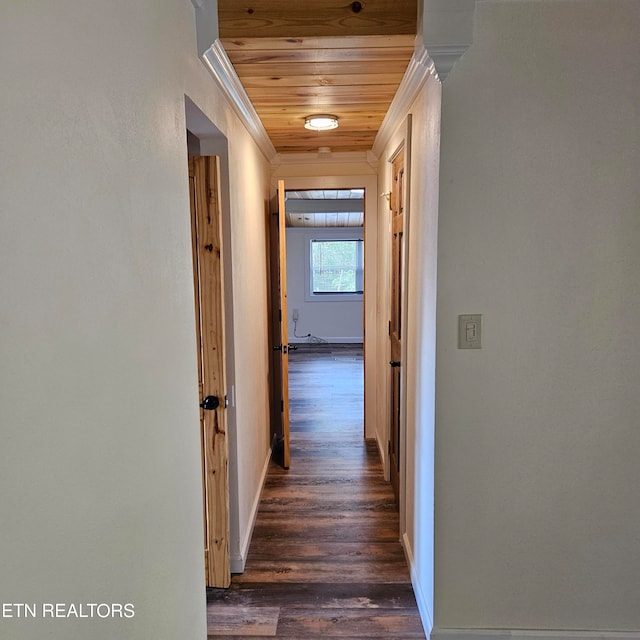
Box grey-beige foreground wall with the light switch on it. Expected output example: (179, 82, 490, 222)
(435, 0, 640, 637)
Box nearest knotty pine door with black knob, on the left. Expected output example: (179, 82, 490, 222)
(189, 157, 231, 587)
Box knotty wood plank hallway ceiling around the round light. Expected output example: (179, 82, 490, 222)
(218, 0, 417, 153)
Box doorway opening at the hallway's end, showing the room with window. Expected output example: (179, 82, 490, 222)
(284, 187, 365, 460)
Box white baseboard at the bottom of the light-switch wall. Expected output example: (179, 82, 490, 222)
(430, 632, 640, 640)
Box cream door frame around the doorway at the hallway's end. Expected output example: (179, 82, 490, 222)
(271, 175, 381, 447)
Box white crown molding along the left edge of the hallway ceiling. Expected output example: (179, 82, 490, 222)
(202, 40, 276, 162)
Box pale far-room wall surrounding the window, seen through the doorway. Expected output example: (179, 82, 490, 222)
(287, 227, 364, 344)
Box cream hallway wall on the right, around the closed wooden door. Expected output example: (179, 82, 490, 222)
(377, 75, 441, 632)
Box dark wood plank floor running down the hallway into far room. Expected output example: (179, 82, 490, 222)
(207, 344, 425, 640)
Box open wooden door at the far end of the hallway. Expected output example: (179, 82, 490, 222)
(269, 180, 291, 469)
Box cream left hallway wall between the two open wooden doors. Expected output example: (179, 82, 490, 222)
(218, 123, 271, 570)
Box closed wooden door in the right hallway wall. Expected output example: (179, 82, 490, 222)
(389, 149, 405, 501)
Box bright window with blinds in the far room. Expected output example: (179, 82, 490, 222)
(310, 240, 364, 296)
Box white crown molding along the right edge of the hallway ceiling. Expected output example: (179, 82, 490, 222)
(372, 44, 437, 158)
